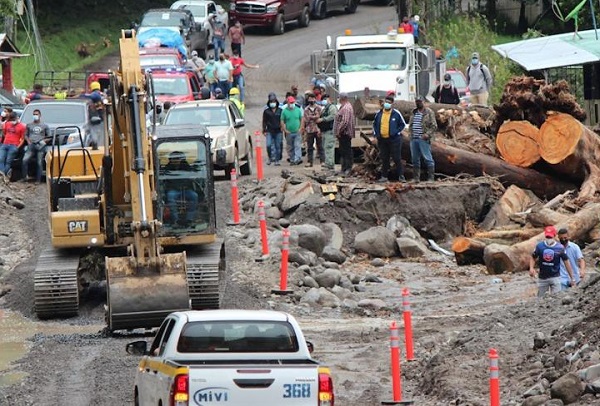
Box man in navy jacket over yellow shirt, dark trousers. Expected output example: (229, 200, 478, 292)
(373, 95, 406, 182)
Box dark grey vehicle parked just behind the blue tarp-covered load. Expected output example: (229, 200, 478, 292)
(137, 8, 208, 58)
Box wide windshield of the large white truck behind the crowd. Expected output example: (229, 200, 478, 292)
(338, 48, 406, 73)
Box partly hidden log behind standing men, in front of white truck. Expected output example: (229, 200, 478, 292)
(352, 97, 494, 123)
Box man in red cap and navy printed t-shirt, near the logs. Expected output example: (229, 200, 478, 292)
(529, 226, 575, 297)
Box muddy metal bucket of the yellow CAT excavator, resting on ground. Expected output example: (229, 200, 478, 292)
(106, 253, 190, 331)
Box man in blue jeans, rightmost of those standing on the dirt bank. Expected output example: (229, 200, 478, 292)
(408, 96, 437, 182)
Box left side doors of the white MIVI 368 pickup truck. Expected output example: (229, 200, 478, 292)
(141, 318, 175, 405)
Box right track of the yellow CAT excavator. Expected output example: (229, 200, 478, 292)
(186, 240, 225, 310)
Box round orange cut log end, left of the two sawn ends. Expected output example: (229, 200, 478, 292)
(496, 121, 540, 168)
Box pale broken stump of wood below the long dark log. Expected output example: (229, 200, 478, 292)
(479, 185, 541, 230)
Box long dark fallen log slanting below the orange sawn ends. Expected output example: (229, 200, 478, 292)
(402, 140, 577, 199)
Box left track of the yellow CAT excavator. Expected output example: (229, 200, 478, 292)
(34, 248, 79, 319)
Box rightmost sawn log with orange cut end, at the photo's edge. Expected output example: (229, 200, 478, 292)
(538, 113, 600, 200)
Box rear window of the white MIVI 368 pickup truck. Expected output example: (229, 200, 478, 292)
(177, 321, 299, 353)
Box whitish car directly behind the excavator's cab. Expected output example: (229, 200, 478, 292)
(163, 100, 252, 178)
